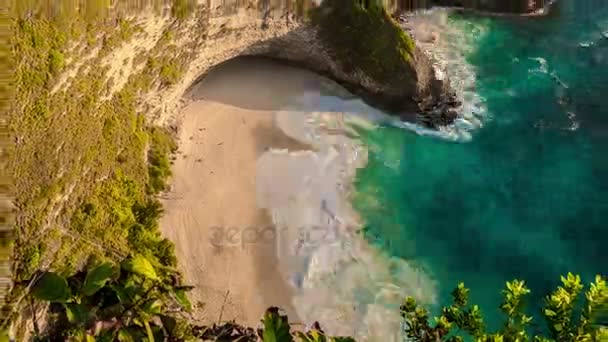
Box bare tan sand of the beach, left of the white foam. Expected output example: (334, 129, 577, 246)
(161, 59, 326, 325)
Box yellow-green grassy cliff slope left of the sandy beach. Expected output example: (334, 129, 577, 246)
(8, 0, 197, 332)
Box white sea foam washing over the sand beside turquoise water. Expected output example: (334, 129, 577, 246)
(256, 91, 436, 342)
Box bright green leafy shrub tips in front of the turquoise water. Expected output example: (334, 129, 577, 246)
(401, 274, 608, 342)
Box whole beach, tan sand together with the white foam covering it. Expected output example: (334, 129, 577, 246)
(161, 58, 435, 342)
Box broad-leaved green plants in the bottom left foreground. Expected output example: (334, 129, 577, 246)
(31, 255, 194, 341)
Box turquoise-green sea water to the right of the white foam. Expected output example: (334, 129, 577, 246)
(354, 0, 608, 327)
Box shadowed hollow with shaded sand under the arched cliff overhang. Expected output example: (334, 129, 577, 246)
(185, 26, 416, 121)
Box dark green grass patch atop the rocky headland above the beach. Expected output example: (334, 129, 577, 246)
(311, 0, 415, 84)
